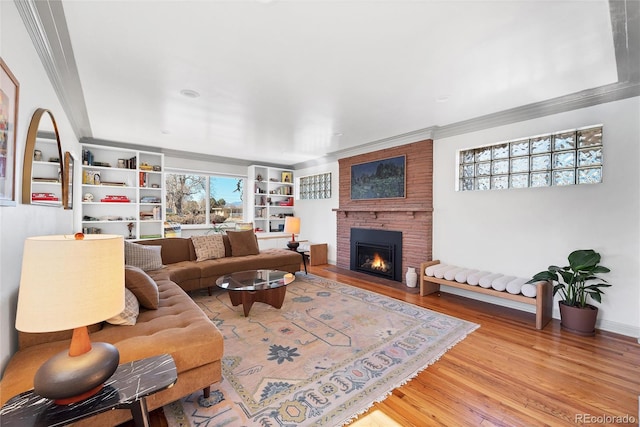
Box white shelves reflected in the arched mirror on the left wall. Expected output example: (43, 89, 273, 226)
(31, 136, 62, 206)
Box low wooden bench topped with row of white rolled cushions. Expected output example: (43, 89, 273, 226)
(420, 260, 553, 329)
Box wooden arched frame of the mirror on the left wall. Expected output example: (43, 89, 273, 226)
(22, 108, 64, 206)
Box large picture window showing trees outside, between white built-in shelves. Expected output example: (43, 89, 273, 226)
(165, 173, 245, 228)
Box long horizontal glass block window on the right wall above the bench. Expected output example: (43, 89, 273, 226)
(458, 126, 603, 191)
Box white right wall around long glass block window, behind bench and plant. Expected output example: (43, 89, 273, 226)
(433, 97, 640, 337)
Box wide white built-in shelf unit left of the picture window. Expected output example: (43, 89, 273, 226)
(82, 144, 165, 239)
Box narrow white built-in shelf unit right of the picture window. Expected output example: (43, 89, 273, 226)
(248, 165, 294, 233)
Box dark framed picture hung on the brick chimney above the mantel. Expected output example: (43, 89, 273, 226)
(351, 156, 406, 200)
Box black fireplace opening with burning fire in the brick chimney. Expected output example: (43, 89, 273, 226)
(350, 228, 402, 282)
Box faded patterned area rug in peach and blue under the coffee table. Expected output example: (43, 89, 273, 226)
(164, 274, 478, 427)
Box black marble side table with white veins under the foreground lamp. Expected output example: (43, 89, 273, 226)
(0, 354, 178, 427)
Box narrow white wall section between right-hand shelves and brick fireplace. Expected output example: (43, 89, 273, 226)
(294, 162, 339, 264)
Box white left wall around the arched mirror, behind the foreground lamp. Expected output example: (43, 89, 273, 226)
(0, 1, 79, 371)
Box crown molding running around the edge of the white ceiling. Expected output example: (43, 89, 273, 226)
(14, 0, 640, 169)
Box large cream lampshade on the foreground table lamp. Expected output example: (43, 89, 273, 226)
(16, 234, 124, 332)
